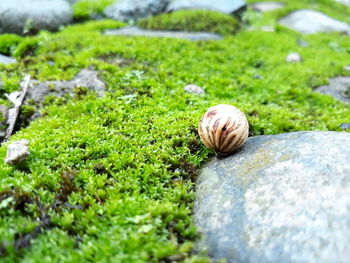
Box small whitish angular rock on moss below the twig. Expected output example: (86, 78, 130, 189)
(5, 139, 29, 165)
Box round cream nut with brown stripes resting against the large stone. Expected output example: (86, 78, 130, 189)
(198, 104, 249, 155)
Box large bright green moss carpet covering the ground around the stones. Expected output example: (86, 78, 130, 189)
(0, 0, 350, 262)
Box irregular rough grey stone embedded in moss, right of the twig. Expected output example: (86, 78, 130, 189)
(24, 69, 106, 118)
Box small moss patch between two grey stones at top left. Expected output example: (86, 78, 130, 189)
(73, 0, 116, 21)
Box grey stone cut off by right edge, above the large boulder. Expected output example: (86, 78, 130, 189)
(315, 77, 350, 104)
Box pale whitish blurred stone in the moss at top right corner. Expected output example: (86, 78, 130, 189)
(280, 9, 350, 34)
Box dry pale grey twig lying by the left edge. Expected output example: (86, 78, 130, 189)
(4, 75, 30, 142)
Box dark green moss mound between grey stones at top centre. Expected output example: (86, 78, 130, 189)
(138, 10, 239, 35)
